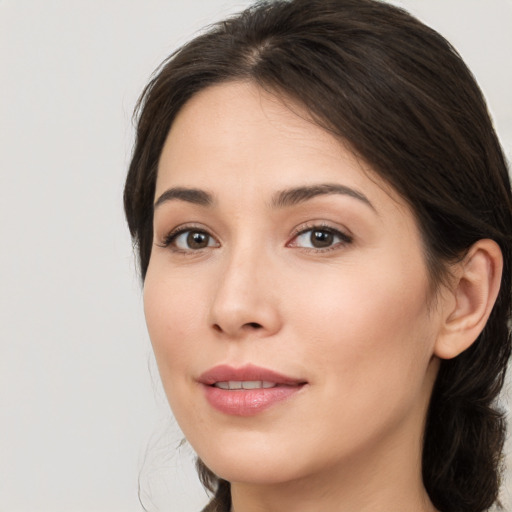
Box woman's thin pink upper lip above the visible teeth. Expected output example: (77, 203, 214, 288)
(198, 364, 306, 386)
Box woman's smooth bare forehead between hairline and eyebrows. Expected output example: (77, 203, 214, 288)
(156, 82, 404, 212)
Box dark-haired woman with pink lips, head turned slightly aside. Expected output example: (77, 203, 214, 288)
(125, 0, 512, 512)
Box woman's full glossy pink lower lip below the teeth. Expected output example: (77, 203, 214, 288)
(204, 385, 303, 416)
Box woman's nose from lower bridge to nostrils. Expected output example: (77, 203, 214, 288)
(210, 245, 281, 339)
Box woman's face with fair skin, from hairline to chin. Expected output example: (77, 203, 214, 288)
(144, 83, 440, 484)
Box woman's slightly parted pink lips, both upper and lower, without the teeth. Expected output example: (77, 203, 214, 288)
(198, 364, 307, 416)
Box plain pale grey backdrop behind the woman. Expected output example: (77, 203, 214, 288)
(0, 0, 512, 512)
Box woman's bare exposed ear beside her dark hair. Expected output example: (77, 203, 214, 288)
(434, 239, 503, 359)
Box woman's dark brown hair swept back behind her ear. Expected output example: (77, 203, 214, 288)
(124, 0, 512, 512)
